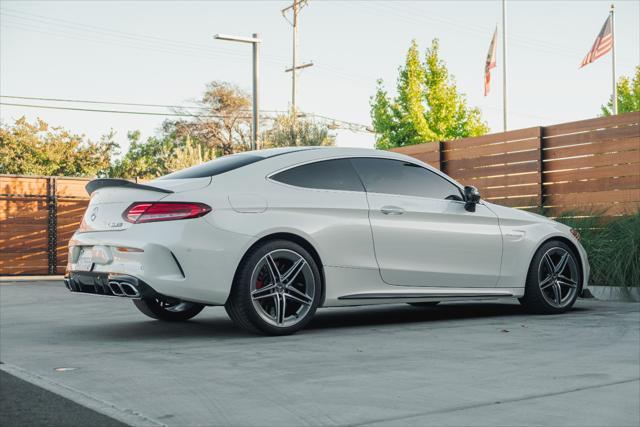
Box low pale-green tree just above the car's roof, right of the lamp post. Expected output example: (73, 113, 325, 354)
(261, 112, 335, 148)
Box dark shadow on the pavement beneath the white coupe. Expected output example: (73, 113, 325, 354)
(62, 303, 589, 341)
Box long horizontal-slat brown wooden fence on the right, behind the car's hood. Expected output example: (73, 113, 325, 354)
(394, 112, 640, 216)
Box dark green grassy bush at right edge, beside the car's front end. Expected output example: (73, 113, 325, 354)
(556, 211, 640, 287)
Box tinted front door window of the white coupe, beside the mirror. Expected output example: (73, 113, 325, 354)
(352, 158, 462, 200)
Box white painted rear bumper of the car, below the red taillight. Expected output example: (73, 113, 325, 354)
(67, 218, 252, 305)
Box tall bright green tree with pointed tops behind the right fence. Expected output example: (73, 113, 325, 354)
(371, 39, 489, 149)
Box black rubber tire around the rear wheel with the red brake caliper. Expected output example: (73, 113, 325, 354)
(224, 240, 322, 335)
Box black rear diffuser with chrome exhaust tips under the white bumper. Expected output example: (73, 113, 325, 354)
(64, 271, 158, 299)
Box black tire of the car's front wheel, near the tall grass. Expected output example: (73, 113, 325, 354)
(519, 240, 582, 314)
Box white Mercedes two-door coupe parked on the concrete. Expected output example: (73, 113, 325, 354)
(65, 147, 589, 335)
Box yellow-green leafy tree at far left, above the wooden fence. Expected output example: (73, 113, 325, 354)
(0, 117, 118, 176)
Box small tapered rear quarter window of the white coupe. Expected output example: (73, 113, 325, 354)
(271, 159, 364, 191)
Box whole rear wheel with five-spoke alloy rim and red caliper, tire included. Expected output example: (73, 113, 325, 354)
(225, 240, 321, 335)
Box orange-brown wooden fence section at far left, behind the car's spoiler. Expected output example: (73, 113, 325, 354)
(0, 175, 90, 275)
